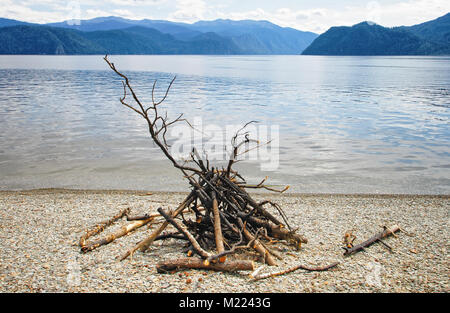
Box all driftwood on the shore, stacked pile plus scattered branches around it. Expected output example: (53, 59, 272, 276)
(79, 56, 404, 279)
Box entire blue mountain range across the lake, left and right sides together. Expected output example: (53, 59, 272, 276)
(0, 13, 450, 55)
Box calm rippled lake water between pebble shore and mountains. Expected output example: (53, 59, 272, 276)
(0, 56, 450, 194)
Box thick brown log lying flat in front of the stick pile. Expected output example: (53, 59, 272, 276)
(156, 258, 255, 273)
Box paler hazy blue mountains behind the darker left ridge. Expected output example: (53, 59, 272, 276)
(43, 16, 318, 54)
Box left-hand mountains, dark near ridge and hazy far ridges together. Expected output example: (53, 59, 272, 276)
(0, 17, 318, 54)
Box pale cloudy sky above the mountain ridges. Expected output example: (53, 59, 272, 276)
(0, 0, 450, 33)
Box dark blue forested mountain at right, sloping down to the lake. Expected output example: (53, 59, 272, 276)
(303, 13, 450, 55)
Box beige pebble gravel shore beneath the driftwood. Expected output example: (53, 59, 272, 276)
(0, 189, 450, 292)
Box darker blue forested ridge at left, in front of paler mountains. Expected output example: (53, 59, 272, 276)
(0, 25, 240, 54)
